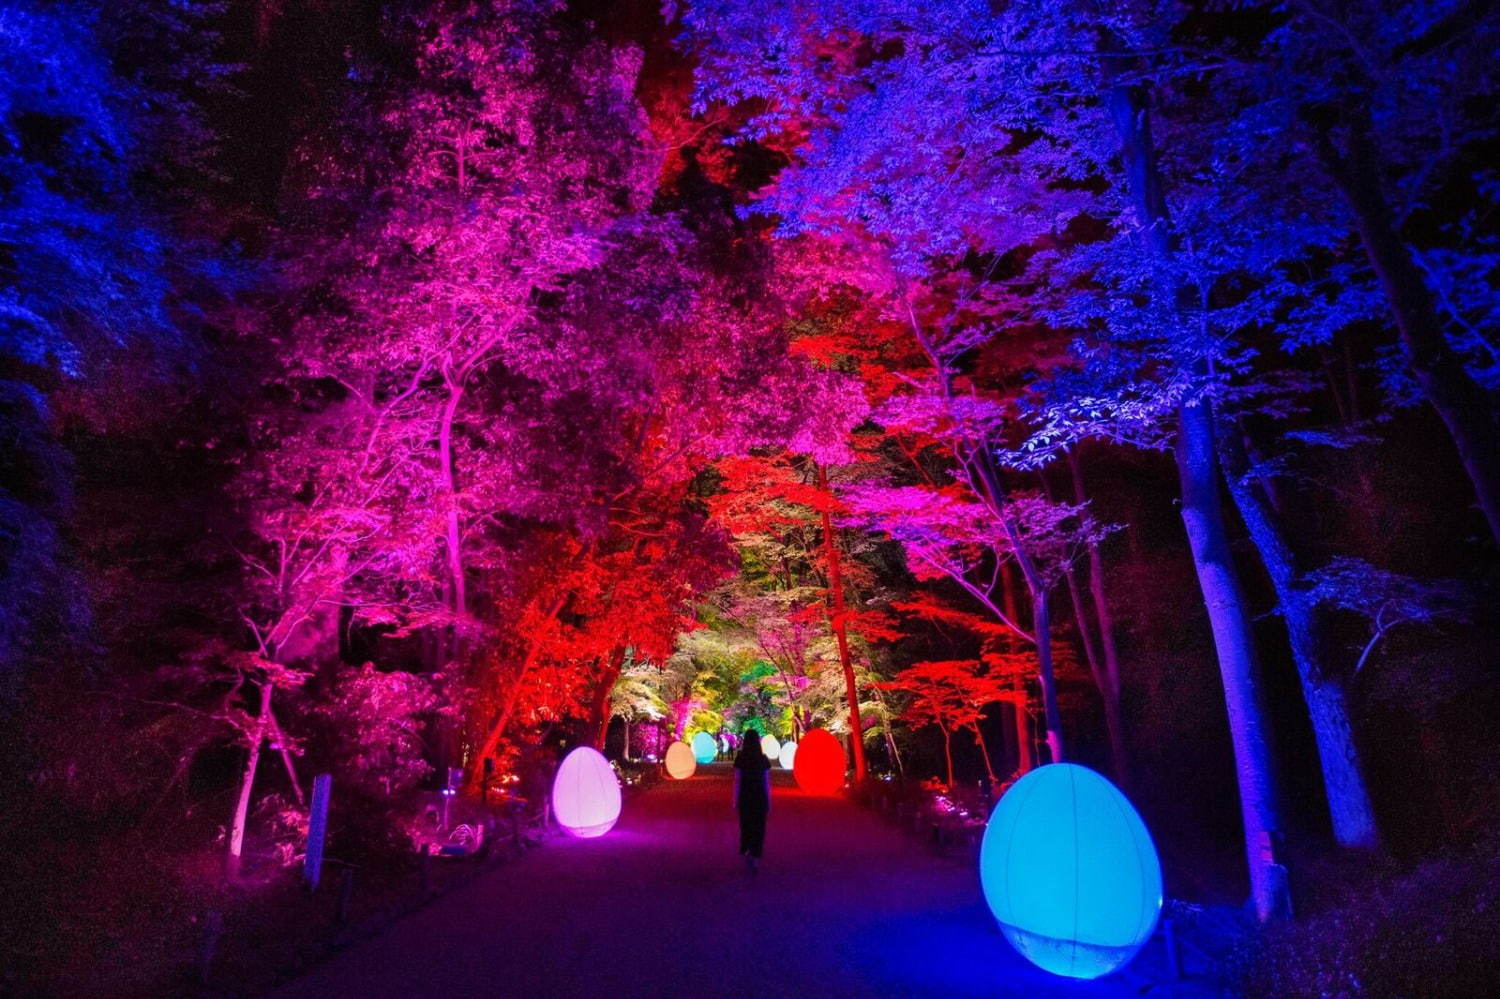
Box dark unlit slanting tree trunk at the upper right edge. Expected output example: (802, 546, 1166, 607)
(1316, 116, 1500, 543)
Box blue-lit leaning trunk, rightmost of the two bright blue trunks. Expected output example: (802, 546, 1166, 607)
(1217, 426, 1380, 849)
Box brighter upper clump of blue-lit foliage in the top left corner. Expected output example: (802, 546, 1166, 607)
(0, 3, 171, 377)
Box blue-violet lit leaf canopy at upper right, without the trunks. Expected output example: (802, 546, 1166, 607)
(686, 0, 1500, 447)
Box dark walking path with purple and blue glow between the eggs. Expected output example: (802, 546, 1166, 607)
(279, 768, 1200, 999)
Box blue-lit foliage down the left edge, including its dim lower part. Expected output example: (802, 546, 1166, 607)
(0, 0, 180, 663)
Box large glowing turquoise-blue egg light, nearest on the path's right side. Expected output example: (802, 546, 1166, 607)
(980, 764, 1161, 978)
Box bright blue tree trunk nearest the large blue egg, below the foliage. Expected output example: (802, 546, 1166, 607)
(1176, 399, 1290, 921)
